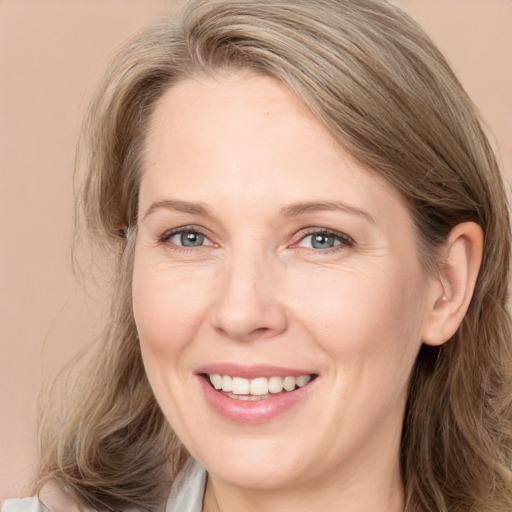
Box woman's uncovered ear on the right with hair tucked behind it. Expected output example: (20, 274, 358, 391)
(422, 222, 484, 346)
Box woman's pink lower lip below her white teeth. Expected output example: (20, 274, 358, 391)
(197, 375, 314, 423)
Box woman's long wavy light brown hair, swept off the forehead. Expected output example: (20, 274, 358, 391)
(37, 0, 512, 512)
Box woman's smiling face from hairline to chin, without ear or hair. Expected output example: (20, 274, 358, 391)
(133, 73, 432, 489)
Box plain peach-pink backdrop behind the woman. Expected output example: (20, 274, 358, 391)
(0, 0, 512, 499)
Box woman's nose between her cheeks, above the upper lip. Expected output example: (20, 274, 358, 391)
(211, 250, 288, 341)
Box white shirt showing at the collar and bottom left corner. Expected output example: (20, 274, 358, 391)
(0, 457, 206, 512)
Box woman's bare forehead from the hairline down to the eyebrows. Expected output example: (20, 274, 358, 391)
(140, 73, 412, 228)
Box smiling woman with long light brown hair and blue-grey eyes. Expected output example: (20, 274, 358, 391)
(2, 0, 512, 512)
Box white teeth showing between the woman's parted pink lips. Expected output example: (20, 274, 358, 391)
(202, 373, 317, 401)
